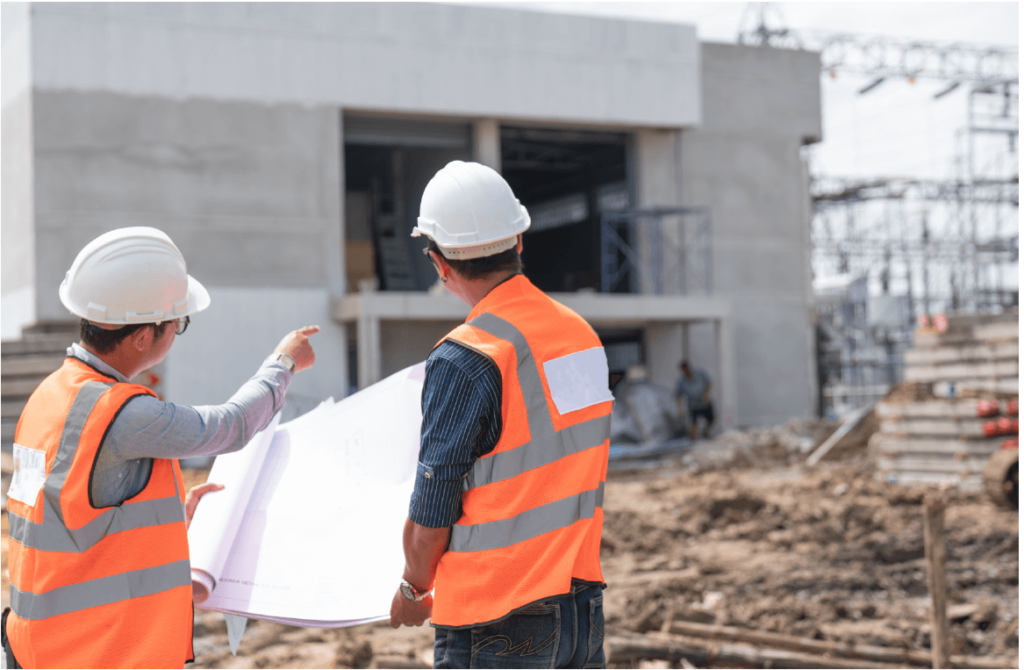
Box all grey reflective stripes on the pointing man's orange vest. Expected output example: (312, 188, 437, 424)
(8, 366, 191, 620)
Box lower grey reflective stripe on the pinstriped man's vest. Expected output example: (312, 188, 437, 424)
(449, 481, 604, 552)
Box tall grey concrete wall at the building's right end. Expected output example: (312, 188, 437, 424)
(682, 44, 821, 424)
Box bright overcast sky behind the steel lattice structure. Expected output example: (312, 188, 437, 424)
(438, 1, 1020, 183)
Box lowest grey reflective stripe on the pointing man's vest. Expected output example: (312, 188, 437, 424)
(10, 560, 191, 621)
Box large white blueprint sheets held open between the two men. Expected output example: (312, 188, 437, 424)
(188, 364, 424, 627)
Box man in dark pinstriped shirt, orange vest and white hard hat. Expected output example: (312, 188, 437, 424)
(391, 161, 611, 668)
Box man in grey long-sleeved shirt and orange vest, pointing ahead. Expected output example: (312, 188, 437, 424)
(0, 227, 318, 669)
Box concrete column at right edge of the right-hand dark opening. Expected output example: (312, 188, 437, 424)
(636, 129, 682, 293)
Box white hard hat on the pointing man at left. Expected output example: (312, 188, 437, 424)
(60, 226, 210, 326)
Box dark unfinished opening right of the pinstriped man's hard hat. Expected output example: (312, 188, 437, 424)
(501, 126, 632, 292)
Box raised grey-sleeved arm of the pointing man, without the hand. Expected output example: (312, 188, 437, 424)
(103, 364, 292, 460)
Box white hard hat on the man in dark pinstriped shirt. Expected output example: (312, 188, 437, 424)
(413, 161, 529, 260)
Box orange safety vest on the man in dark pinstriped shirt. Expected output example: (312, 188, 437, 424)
(431, 276, 611, 627)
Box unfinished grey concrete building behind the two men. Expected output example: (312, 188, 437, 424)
(0, 2, 821, 441)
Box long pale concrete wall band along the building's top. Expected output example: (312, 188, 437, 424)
(33, 0, 700, 127)
